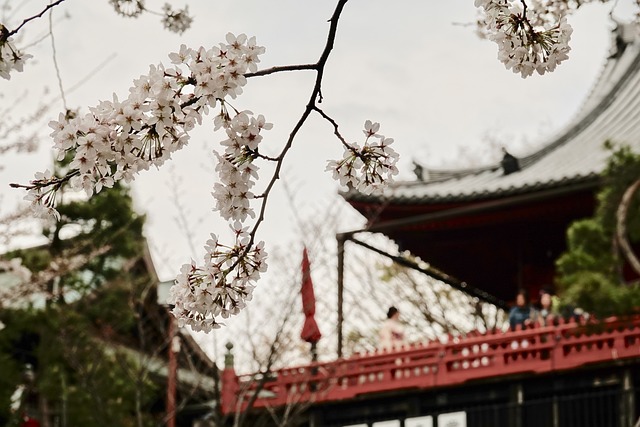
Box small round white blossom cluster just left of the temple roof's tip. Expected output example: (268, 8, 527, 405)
(326, 120, 399, 194)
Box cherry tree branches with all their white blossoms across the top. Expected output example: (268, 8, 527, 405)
(5, 0, 640, 331)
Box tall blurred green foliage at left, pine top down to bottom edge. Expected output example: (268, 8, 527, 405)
(0, 177, 162, 426)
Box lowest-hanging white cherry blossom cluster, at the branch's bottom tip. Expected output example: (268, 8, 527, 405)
(167, 226, 267, 332)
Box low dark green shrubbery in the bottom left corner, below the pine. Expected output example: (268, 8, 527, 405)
(0, 305, 161, 426)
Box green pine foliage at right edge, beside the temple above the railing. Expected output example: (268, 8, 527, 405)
(556, 143, 640, 317)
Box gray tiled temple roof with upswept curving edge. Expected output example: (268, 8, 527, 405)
(346, 25, 640, 203)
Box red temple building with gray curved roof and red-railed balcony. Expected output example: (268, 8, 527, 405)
(222, 26, 640, 427)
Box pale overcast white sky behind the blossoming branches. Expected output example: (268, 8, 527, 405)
(0, 0, 636, 294)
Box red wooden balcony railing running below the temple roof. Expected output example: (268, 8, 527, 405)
(222, 317, 640, 413)
